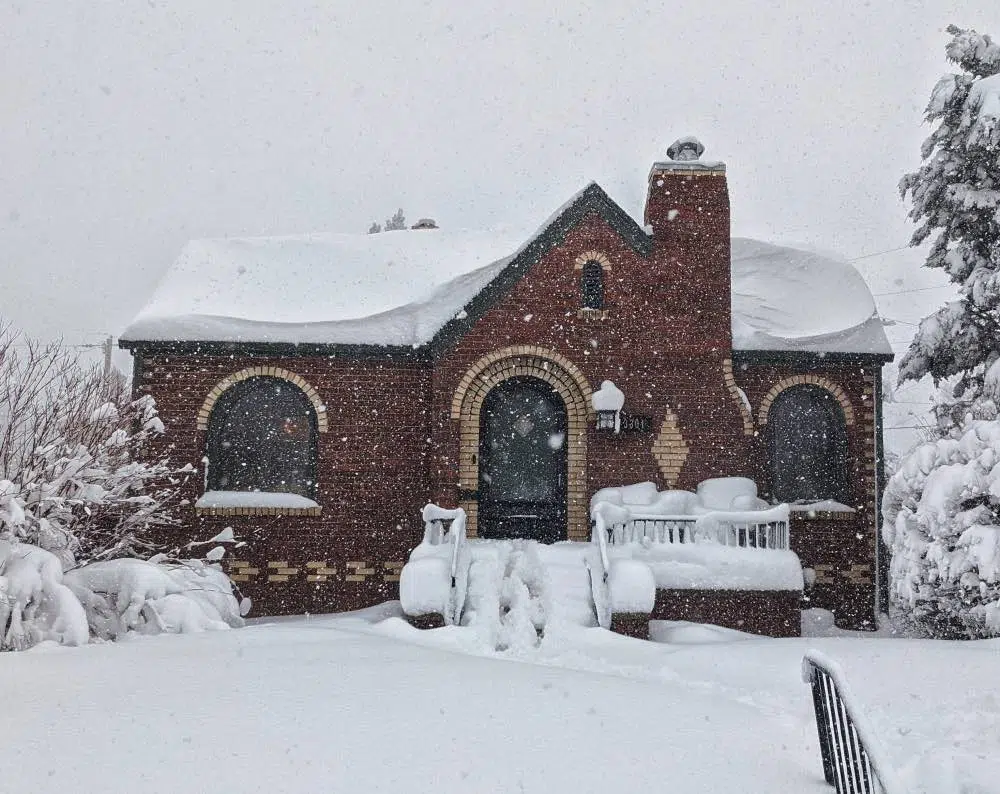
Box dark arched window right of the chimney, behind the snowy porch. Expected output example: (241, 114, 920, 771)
(767, 386, 850, 504)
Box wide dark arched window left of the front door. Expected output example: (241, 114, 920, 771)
(208, 377, 317, 498)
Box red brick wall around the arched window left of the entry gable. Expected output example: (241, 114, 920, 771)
(136, 355, 430, 614)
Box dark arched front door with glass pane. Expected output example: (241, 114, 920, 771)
(479, 378, 566, 543)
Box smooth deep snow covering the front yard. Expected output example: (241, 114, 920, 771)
(0, 604, 1000, 794)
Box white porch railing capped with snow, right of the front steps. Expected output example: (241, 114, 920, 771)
(591, 502, 789, 550)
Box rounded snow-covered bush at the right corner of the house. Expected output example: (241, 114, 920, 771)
(882, 421, 1000, 637)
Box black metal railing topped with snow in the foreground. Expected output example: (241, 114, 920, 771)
(802, 651, 904, 794)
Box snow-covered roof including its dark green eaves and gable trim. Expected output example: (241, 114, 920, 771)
(119, 183, 892, 366)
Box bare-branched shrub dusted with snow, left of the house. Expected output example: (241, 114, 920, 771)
(0, 329, 191, 567)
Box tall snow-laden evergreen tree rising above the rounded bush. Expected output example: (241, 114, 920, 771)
(900, 26, 1000, 430)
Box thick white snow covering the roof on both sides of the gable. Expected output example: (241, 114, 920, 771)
(122, 207, 890, 353)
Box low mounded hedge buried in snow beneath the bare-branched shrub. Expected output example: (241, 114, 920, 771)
(0, 540, 243, 650)
